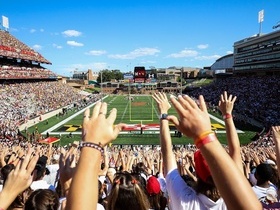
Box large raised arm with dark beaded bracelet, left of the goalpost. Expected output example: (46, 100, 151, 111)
(66, 102, 124, 210)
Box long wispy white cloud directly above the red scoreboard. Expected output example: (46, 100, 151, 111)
(109, 47, 160, 59)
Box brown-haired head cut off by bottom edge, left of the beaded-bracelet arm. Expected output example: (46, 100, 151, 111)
(24, 189, 59, 210)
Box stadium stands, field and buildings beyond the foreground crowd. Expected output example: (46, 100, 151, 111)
(0, 25, 280, 145)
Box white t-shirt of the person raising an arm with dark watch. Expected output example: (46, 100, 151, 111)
(166, 168, 227, 210)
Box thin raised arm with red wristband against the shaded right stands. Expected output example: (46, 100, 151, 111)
(219, 91, 243, 172)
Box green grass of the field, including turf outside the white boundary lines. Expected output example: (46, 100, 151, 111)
(28, 95, 255, 145)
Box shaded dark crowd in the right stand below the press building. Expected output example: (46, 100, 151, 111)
(188, 75, 280, 129)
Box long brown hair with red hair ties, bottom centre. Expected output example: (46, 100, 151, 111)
(107, 173, 149, 210)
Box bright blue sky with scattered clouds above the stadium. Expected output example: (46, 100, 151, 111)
(0, 0, 280, 76)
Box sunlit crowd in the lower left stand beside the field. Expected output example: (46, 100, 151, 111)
(0, 82, 100, 143)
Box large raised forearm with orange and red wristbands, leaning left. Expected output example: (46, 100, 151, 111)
(168, 96, 262, 210)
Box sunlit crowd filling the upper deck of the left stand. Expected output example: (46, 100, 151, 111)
(0, 30, 51, 64)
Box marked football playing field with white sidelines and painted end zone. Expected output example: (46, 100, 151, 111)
(42, 95, 243, 135)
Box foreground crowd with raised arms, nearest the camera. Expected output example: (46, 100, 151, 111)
(0, 93, 280, 210)
